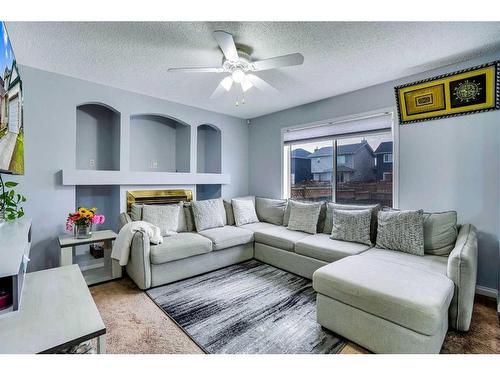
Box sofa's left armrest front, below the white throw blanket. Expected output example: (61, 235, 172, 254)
(127, 232, 151, 289)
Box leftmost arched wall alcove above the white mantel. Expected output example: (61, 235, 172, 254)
(75, 103, 120, 171)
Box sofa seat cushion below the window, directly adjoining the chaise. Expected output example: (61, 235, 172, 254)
(295, 233, 370, 262)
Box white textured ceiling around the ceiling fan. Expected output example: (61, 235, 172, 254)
(7, 22, 500, 119)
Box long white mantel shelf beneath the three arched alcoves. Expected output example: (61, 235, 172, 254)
(62, 169, 231, 185)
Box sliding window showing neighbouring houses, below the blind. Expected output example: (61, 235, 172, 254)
(284, 116, 393, 207)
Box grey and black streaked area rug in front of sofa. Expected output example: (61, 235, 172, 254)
(147, 260, 345, 354)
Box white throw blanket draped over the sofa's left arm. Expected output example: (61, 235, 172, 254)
(111, 221, 163, 266)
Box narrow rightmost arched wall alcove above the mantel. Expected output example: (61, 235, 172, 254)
(197, 124, 221, 173)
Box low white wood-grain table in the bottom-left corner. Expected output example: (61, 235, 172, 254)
(0, 265, 106, 354)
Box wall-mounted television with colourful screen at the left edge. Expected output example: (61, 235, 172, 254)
(0, 21, 24, 174)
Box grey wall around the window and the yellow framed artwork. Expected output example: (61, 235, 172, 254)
(249, 51, 500, 289)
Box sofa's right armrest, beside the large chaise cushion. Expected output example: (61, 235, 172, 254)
(447, 224, 477, 331)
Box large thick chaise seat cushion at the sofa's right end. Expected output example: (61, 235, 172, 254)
(313, 256, 454, 335)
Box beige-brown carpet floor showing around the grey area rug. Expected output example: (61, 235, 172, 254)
(90, 278, 500, 354)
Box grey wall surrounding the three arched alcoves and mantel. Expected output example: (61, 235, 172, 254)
(6, 66, 248, 270)
